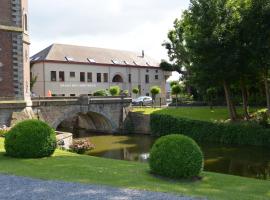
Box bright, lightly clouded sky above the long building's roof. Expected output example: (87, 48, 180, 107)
(29, 0, 189, 79)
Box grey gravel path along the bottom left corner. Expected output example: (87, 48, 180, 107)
(0, 174, 205, 200)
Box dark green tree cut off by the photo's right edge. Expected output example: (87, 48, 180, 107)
(242, 0, 270, 114)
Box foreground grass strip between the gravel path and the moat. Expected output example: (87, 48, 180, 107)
(0, 138, 270, 200)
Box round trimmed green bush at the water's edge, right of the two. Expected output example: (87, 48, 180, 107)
(149, 135, 203, 178)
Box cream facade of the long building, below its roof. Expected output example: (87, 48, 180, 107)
(31, 61, 168, 98)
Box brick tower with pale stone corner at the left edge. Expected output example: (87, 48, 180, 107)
(0, 0, 30, 102)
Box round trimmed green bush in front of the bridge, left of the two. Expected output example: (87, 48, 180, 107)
(5, 120, 56, 158)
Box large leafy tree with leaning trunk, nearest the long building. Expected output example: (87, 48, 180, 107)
(166, 0, 253, 120)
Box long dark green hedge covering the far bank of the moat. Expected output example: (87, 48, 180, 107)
(150, 114, 270, 147)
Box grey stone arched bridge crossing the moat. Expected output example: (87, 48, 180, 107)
(0, 96, 131, 133)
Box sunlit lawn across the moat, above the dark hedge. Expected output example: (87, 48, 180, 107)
(133, 107, 258, 121)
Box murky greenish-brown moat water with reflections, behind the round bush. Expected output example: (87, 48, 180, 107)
(75, 131, 270, 179)
